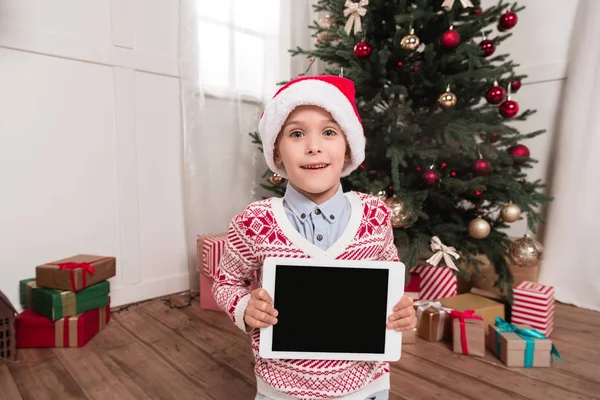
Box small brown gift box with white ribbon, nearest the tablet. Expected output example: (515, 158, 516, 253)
(413, 300, 452, 342)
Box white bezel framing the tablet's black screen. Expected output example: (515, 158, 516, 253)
(259, 257, 406, 362)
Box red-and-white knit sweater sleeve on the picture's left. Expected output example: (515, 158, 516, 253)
(212, 213, 260, 333)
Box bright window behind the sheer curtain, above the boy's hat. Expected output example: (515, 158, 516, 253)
(197, 0, 279, 99)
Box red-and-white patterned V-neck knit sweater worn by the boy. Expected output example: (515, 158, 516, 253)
(213, 192, 399, 399)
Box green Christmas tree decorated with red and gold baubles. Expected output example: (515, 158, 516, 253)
(251, 0, 551, 296)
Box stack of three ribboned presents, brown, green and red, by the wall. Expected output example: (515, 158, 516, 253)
(15, 254, 116, 348)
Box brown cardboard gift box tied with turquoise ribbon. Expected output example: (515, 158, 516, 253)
(487, 325, 552, 367)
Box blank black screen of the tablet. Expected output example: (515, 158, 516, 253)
(272, 265, 389, 354)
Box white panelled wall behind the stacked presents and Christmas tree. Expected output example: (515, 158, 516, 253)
(0, 0, 575, 305)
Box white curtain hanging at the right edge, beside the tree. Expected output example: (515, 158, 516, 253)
(539, 0, 600, 310)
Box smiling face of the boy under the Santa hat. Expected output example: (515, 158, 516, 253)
(274, 106, 350, 204)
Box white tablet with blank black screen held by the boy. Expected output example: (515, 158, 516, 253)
(259, 257, 405, 361)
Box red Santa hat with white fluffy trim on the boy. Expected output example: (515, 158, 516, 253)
(258, 75, 366, 178)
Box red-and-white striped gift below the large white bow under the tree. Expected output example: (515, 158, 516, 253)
(410, 265, 458, 300)
